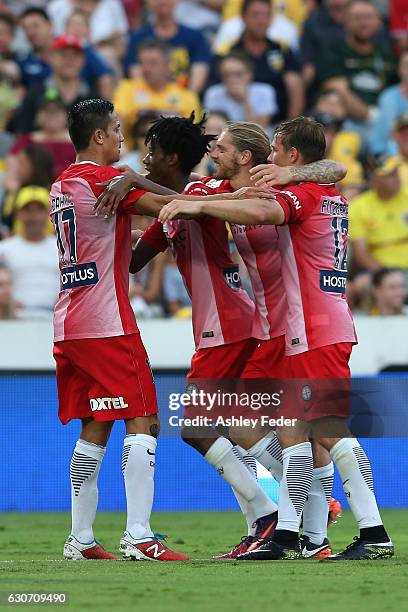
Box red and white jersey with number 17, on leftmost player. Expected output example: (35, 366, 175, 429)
(50, 162, 145, 342)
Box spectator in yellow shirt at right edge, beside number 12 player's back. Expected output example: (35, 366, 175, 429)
(349, 159, 408, 272)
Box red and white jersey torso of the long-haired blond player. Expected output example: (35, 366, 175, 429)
(230, 223, 287, 340)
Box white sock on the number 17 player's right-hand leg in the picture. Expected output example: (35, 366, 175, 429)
(122, 434, 157, 540)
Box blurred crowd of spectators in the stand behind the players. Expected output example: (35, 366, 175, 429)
(0, 0, 408, 319)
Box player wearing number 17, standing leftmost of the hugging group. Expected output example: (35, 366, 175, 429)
(50, 100, 188, 561)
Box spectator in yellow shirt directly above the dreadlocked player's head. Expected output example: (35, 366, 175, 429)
(113, 40, 200, 137)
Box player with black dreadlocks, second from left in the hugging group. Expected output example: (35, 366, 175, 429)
(127, 117, 277, 558)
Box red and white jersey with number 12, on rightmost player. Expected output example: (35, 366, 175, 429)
(274, 183, 357, 355)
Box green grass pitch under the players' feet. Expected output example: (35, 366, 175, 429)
(0, 510, 408, 612)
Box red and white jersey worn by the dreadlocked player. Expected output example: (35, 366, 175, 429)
(142, 178, 254, 349)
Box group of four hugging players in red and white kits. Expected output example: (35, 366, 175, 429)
(51, 100, 394, 561)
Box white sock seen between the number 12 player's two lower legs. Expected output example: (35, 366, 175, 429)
(303, 461, 334, 544)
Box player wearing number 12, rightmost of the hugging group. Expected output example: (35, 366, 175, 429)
(159, 117, 394, 560)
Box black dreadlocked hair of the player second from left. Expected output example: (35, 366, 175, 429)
(145, 111, 216, 174)
